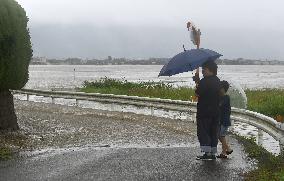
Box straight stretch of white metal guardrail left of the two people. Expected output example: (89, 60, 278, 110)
(13, 89, 196, 113)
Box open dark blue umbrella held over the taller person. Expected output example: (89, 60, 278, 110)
(159, 48, 222, 76)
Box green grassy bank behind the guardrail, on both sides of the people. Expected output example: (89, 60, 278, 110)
(80, 78, 284, 122)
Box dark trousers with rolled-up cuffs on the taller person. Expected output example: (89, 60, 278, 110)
(197, 117, 220, 154)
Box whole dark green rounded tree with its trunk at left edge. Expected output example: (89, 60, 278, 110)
(0, 0, 32, 130)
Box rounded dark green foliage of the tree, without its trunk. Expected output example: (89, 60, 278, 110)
(0, 0, 32, 90)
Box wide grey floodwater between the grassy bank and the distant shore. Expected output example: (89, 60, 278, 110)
(26, 65, 284, 89)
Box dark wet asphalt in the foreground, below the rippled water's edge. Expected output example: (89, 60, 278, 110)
(0, 147, 253, 181)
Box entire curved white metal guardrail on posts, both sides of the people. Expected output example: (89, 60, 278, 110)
(13, 89, 284, 153)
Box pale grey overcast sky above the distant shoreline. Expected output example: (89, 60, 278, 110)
(18, 0, 284, 60)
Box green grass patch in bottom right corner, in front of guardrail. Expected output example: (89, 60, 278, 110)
(237, 136, 284, 181)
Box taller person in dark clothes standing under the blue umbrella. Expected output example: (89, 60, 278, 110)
(195, 61, 220, 160)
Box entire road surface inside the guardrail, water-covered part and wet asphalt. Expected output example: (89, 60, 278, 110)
(0, 102, 253, 181)
